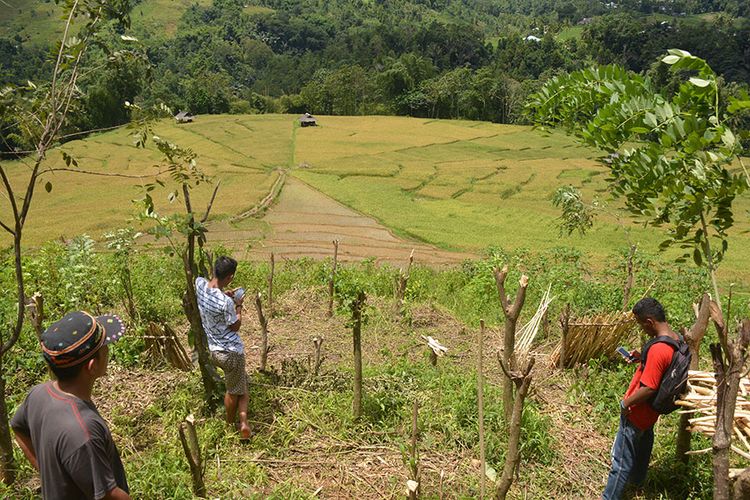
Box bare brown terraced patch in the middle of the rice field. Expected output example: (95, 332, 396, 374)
(210, 177, 476, 265)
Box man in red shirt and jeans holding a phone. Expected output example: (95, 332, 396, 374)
(602, 297, 680, 500)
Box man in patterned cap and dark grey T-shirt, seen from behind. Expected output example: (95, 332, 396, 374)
(10, 311, 130, 500)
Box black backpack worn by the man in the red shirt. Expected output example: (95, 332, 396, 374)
(641, 336, 692, 415)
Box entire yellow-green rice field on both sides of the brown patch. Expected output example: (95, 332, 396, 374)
(3, 115, 750, 284)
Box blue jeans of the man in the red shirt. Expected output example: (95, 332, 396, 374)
(602, 415, 654, 500)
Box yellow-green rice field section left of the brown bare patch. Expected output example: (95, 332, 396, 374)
(0, 115, 292, 245)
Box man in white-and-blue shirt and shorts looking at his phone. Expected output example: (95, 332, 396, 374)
(195, 256, 250, 439)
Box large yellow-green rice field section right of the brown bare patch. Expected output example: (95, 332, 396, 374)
(295, 117, 750, 283)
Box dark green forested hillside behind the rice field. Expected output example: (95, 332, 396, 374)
(0, 0, 750, 149)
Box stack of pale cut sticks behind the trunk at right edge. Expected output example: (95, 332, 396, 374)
(676, 370, 750, 459)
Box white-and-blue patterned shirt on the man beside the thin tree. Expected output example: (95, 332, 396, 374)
(195, 277, 245, 354)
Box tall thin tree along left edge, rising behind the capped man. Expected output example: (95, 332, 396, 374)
(0, 0, 130, 484)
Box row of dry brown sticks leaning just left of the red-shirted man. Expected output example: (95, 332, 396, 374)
(551, 312, 639, 368)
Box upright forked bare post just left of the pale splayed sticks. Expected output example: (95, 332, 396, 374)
(494, 265, 529, 422)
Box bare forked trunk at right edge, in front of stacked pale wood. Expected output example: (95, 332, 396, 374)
(711, 320, 750, 500)
